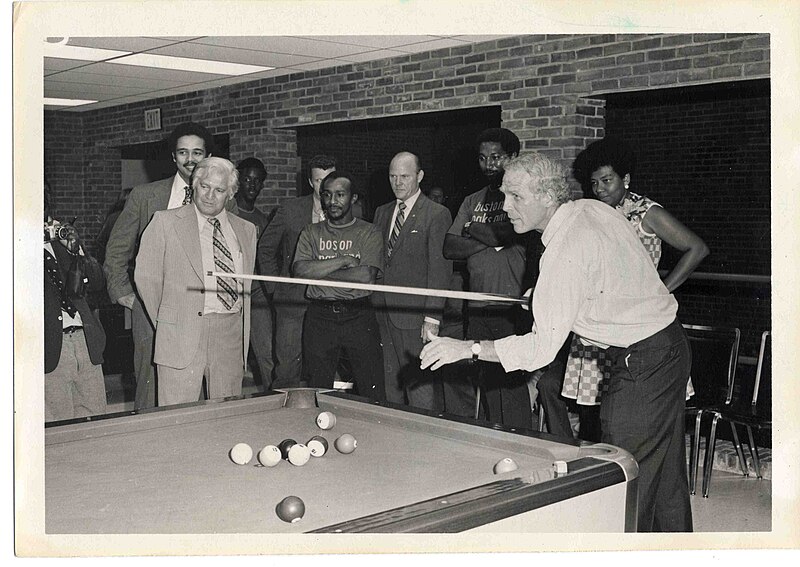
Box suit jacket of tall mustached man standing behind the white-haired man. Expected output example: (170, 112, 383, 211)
(103, 174, 238, 303)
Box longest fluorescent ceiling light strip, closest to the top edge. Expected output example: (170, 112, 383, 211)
(44, 42, 275, 75)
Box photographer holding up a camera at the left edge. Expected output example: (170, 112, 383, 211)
(44, 182, 106, 421)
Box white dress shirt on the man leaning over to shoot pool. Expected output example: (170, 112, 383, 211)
(494, 199, 678, 372)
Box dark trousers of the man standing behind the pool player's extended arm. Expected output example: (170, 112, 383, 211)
(467, 307, 531, 429)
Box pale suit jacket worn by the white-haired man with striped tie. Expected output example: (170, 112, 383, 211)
(134, 204, 256, 369)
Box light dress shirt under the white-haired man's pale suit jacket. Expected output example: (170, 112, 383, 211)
(193, 207, 244, 313)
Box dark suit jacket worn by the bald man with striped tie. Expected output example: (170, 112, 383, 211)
(373, 194, 453, 329)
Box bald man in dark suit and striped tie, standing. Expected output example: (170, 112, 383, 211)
(373, 152, 453, 411)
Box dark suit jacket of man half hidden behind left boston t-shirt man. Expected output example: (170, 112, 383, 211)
(257, 195, 314, 315)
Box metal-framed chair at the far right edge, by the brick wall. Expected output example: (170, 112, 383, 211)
(703, 331, 772, 498)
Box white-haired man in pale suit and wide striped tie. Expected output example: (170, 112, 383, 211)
(134, 157, 256, 406)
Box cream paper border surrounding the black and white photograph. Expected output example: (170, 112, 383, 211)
(4, 0, 800, 557)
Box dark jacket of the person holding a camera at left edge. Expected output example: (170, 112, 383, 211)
(44, 242, 106, 373)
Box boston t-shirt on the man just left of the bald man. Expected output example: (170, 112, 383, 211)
(294, 218, 383, 301)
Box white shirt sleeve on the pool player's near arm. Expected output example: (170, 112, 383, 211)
(494, 236, 589, 372)
